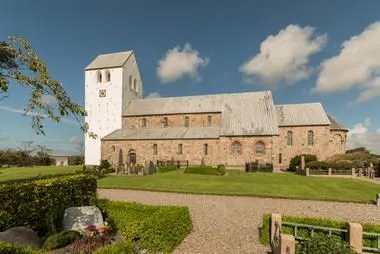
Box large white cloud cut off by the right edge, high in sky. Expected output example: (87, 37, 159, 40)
(314, 21, 380, 102)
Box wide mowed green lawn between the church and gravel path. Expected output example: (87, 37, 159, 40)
(98, 171, 380, 203)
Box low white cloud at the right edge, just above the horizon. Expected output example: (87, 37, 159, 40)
(347, 119, 380, 154)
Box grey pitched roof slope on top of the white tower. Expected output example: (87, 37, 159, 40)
(85, 51, 133, 70)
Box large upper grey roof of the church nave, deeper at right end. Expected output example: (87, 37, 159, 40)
(123, 91, 279, 136)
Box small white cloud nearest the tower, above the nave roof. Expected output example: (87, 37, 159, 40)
(157, 44, 209, 83)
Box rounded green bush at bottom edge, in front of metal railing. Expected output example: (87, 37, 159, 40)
(296, 237, 357, 254)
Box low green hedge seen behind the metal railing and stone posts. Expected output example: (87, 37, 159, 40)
(260, 214, 380, 248)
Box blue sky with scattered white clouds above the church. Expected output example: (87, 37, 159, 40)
(0, 0, 380, 154)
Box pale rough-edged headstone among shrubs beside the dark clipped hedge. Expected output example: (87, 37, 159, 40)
(63, 206, 104, 233)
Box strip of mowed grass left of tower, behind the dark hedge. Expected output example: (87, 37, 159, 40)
(0, 166, 81, 183)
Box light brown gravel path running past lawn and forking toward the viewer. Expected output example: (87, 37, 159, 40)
(98, 189, 380, 254)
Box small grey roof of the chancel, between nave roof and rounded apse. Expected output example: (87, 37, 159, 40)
(276, 103, 330, 126)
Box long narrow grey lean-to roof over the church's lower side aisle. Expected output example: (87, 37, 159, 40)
(102, 127, 220, 140)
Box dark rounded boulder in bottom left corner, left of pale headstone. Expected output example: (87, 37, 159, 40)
(0, 227, 42, 248)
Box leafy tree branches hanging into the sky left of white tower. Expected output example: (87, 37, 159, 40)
(0, 36, 96, 137)
